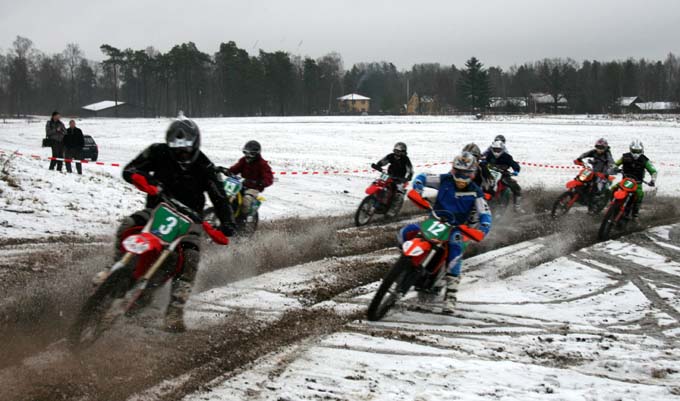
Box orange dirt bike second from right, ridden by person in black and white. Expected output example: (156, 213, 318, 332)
(550, 161, 614, 218)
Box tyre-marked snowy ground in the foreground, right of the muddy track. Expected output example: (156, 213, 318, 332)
(181, 225, 680, 401)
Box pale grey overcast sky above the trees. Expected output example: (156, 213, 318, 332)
(0, 0, 680, 68)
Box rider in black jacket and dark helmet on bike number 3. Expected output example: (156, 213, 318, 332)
(106, 119, 234, 332)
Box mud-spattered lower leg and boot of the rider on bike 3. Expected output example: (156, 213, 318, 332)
(165, 249, 199, 333)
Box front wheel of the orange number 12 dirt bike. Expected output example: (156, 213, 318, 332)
(366, 256, 416, 321)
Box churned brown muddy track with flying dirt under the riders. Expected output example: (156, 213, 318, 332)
(0, 193, 680, 400)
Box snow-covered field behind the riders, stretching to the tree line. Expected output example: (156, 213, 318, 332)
(0, 116, 680, 238)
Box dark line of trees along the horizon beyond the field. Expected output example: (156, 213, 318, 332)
(0, 36, 680, 117)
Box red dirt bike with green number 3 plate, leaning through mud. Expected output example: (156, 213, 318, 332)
(68, 193, 229, 349)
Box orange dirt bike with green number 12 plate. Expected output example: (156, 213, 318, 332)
(367, 190, 484, 321)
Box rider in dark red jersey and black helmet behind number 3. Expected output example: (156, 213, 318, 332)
(228, 141, 274, 224)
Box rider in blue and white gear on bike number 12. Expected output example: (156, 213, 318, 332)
(399, 152, 491, 314)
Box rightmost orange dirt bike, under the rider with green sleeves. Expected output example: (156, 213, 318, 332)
(597, 176, 649, 241)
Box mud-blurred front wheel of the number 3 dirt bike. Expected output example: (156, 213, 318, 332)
(68, 268, 132, 350)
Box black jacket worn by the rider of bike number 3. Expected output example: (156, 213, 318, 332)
(123, 143, 233, 225)
